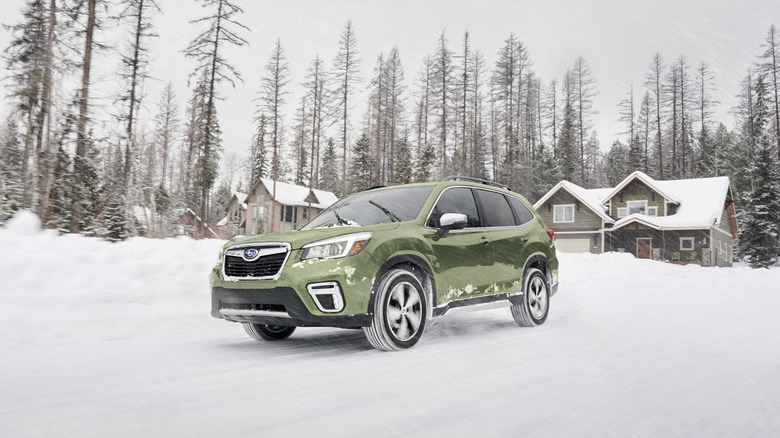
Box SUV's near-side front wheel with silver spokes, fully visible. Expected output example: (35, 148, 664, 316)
(363, 269, 428, 351)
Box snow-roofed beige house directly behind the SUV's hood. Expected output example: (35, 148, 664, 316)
(244, 178, 338, 234)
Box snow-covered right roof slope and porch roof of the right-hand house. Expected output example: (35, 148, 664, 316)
(612, 175, 730, 230)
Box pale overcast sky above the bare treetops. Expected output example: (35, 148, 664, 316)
(0, 0, 780, 163)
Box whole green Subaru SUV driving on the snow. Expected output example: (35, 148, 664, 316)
(210, 177, 558, 350)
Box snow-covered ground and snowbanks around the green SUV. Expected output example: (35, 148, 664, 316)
(0, 210, 780, 438)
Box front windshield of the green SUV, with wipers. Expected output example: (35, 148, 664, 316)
(303, 186, 433, 230)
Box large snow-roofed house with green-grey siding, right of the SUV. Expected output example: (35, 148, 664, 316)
(534, 172, 737, 266)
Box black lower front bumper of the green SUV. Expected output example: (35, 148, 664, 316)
(211, 287, 371, 328)
